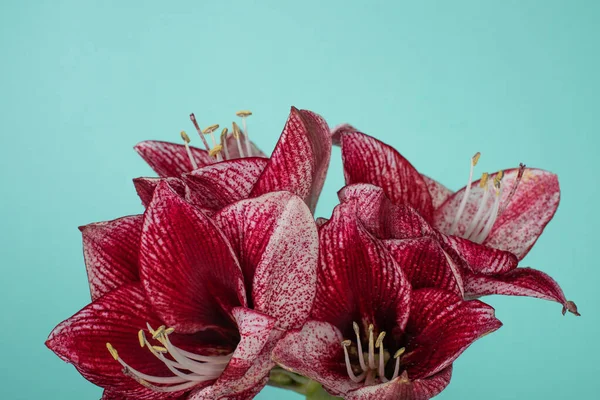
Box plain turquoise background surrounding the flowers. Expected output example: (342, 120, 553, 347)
(0, 0, 600, 400)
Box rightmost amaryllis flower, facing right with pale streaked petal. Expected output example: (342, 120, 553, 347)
(333, 125, 578, 315)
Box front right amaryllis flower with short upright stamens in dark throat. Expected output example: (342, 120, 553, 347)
(273, 201, 501, 400)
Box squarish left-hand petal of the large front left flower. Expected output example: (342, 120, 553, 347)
(79, 215, 143, 300)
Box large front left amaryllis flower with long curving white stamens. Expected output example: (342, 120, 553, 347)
(46, 182, 318, 400)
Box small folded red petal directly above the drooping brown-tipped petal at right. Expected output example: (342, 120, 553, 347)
(440, 235, 519, 275)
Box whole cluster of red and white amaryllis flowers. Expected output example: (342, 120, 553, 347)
(46, 107, 579, 400)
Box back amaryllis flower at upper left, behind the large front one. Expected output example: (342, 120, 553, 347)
(134, 107, 331, 214)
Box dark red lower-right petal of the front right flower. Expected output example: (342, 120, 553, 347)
(402, 289, 502, 379)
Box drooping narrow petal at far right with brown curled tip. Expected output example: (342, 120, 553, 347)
(464, 268, 579, 315)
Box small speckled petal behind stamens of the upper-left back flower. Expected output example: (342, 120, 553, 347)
(134, 140, 215, 178)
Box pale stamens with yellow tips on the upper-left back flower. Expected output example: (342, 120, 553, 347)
(181, 110, 253, 169)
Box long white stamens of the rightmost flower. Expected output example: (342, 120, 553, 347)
(447, 153, 525, 243)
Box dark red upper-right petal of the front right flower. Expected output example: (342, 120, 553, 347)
(384, 237, 464, 296)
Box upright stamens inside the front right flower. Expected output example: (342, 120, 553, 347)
(342, 322, 405, 385)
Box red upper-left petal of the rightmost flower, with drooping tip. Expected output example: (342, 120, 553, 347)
(342, 132, 433, 221)
